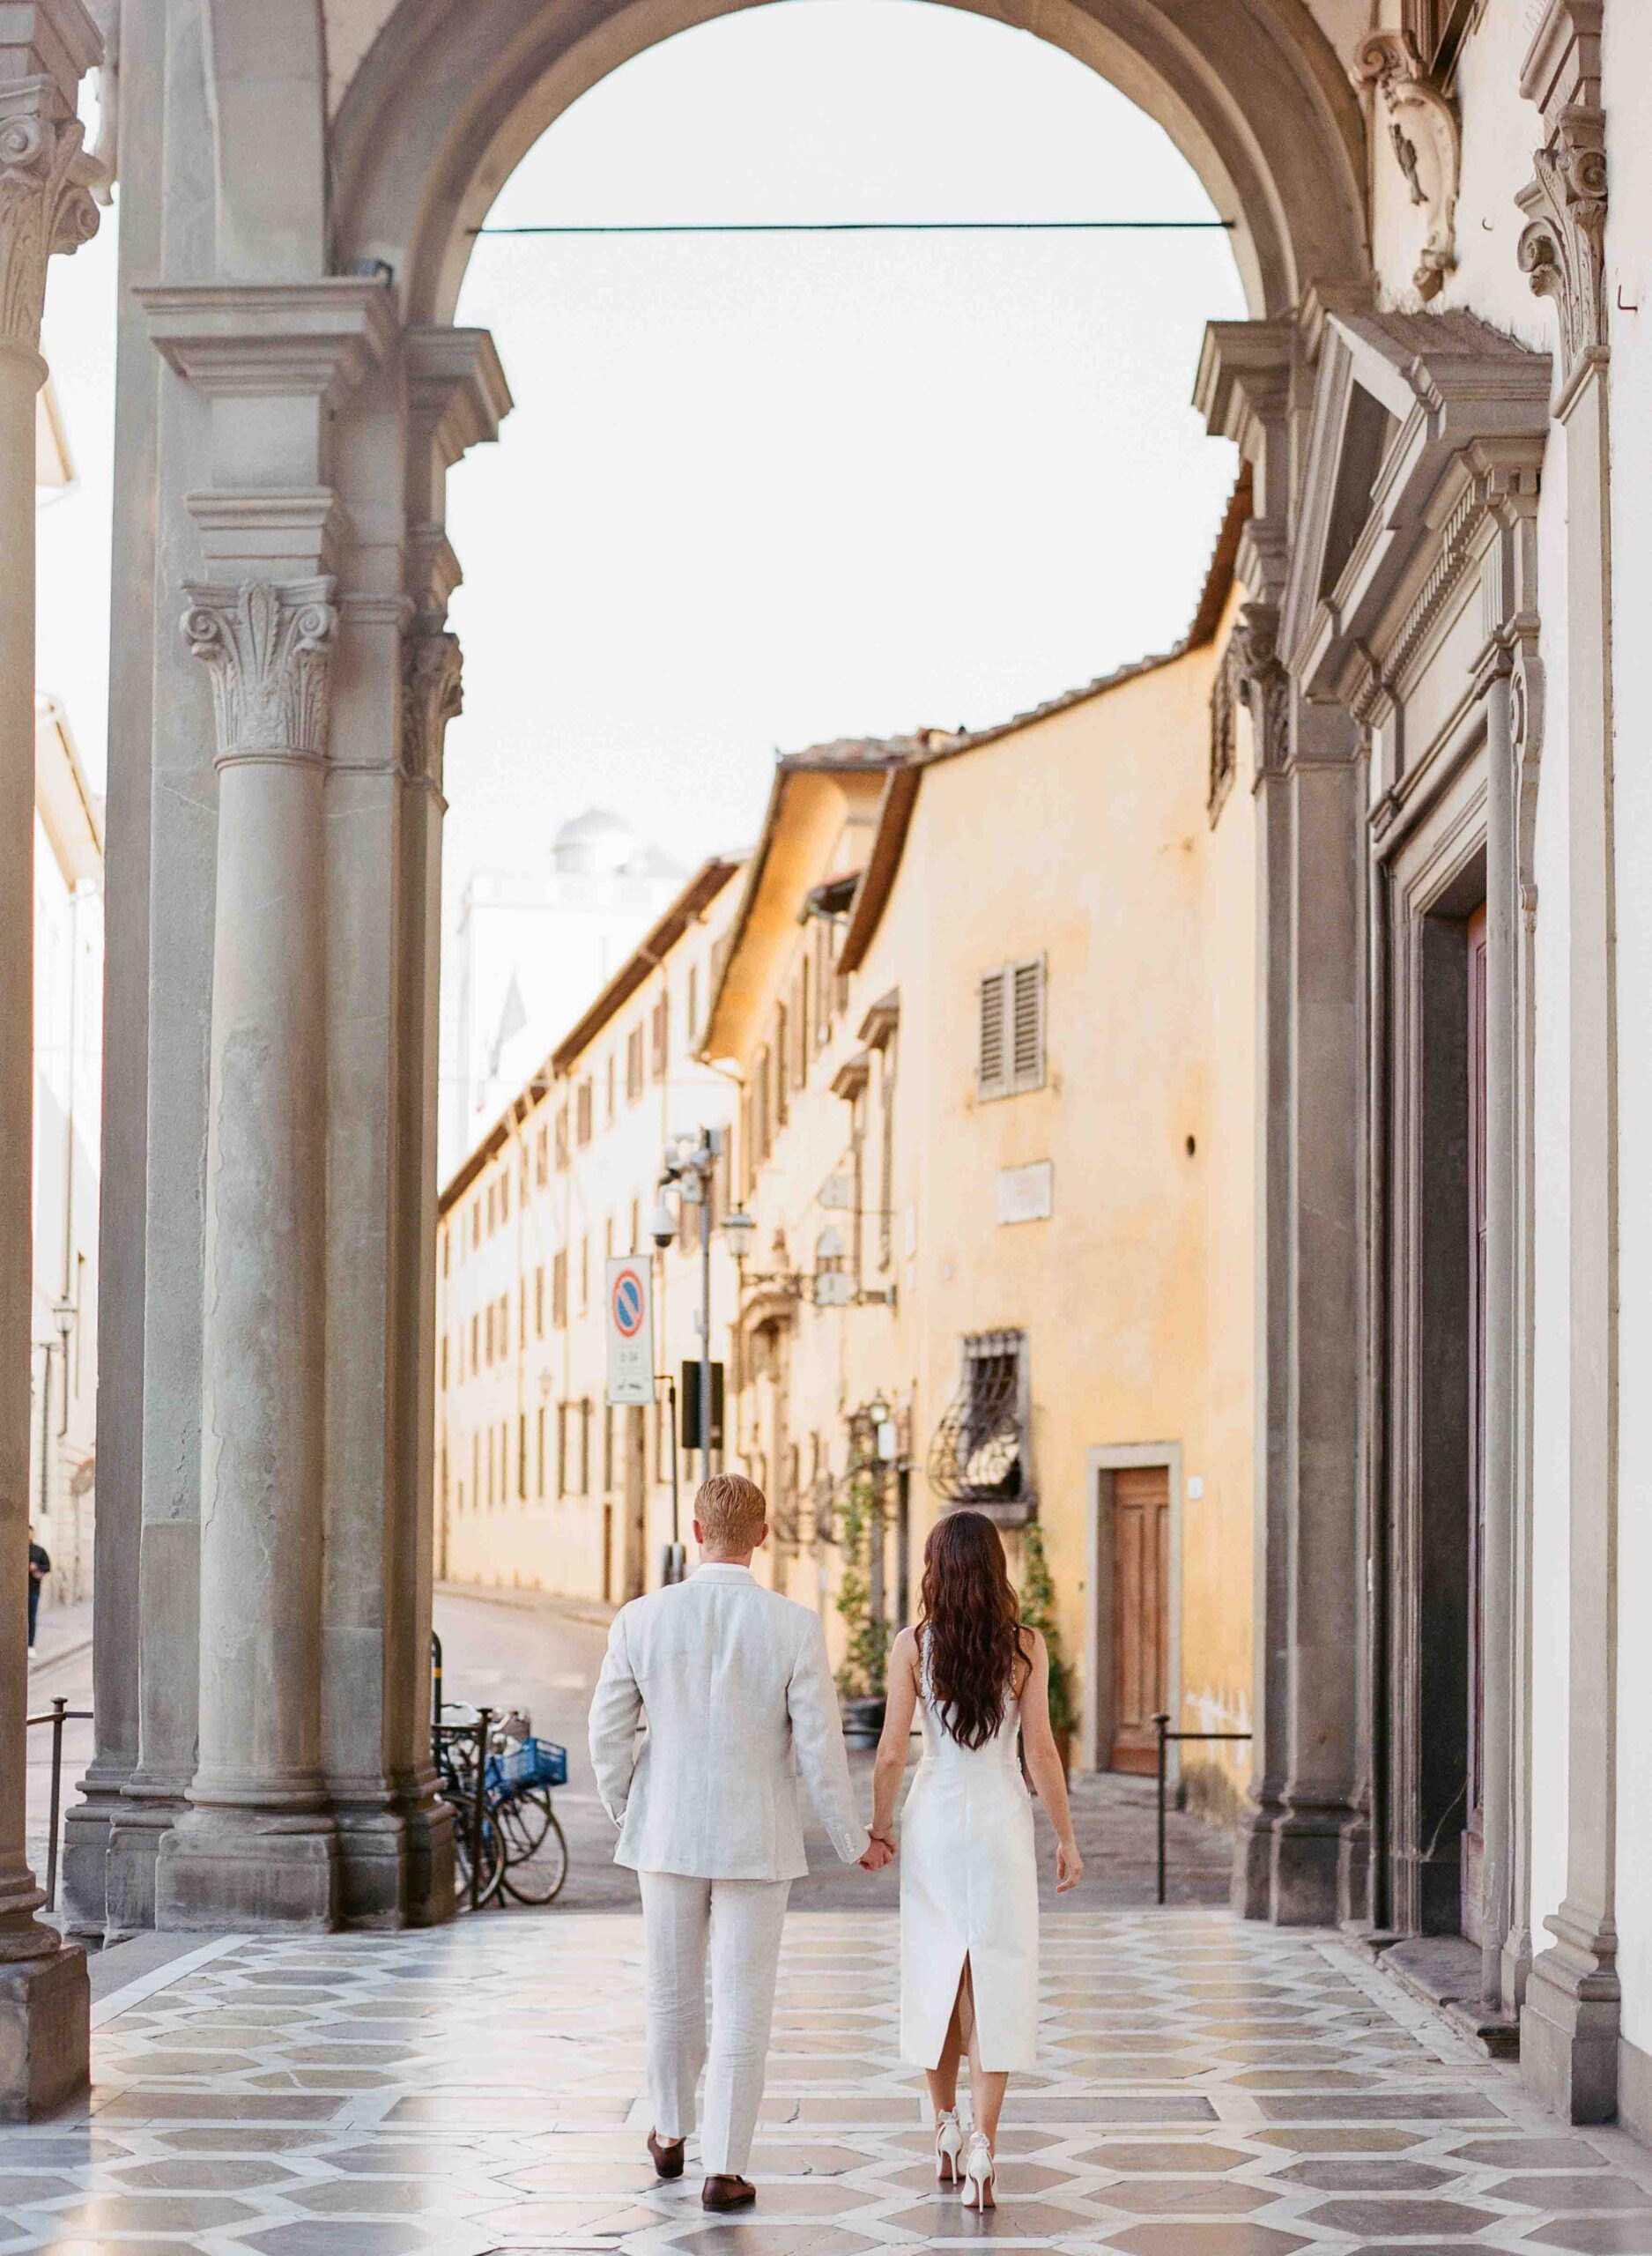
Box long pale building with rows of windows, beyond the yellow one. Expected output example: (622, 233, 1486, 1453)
(433, 862, 738, 1607)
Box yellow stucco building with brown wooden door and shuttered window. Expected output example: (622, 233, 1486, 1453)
(704, 494, 1257, 1812)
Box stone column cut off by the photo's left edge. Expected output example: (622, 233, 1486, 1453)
(0, 0, 100, 2120)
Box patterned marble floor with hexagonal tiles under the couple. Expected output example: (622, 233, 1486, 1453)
(0, 1911, 1652, 2256)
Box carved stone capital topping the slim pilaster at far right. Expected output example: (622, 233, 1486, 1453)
(1515, 0, 1607, 415)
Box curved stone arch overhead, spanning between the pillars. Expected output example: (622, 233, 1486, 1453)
(330, 0, 1370, 323)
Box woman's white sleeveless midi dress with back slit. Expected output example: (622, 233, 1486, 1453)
(900, 1659, 1038, 2074)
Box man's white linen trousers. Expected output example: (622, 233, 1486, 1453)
(636, 1873, 792, 2177)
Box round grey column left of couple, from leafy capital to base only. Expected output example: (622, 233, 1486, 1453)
(156, 575, 337, 1926)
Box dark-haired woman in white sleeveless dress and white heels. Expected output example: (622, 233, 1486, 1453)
(871, 1511, 1084, 2208)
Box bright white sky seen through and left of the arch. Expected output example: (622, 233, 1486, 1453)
(39, 0, 1243, 900)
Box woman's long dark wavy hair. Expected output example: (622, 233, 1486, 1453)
(919, 1511, 1025, 1748)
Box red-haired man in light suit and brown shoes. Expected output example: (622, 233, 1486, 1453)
(591, 1473, 889, 2211)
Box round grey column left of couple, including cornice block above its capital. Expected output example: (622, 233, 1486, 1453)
(140, 278, 393, 1929)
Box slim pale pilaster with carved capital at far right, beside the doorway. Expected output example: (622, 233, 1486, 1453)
(1519, 0, 1620, 2123)
